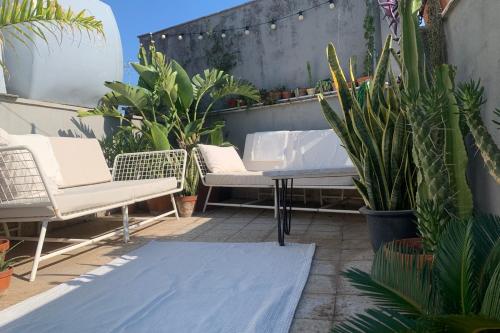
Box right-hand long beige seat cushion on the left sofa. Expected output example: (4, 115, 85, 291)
(55, 178, 177, 214)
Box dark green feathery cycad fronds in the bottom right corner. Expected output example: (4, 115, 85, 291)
(333, 215, 500, 333)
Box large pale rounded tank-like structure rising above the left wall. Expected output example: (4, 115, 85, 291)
(4, 0, 123, 107)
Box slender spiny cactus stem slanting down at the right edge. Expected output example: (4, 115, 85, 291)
(457, 81, 500, 184)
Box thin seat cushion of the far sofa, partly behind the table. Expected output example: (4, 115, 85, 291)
(205, 169, 356, 188)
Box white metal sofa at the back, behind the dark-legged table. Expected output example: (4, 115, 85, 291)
(194, 130, 359, 214)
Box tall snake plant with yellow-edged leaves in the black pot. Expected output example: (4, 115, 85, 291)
(318, 36, 416, 211)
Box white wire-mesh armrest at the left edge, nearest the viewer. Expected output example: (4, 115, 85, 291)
(0, 146, 57, 206)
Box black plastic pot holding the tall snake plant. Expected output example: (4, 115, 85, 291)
(359, 207, 417, 252)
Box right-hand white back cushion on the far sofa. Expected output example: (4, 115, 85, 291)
(286, 130, 345, 170)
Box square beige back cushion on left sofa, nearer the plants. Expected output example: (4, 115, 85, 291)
(50, 138, 111, 188)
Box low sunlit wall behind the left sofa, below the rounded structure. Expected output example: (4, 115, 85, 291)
(0, 94, 117, 139)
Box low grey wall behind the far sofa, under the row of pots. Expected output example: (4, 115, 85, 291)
(210, 95, 340, 153)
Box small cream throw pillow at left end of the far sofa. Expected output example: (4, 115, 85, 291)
(198, 145, 247, 173)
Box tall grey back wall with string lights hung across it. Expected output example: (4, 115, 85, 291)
(141, 0, 366, 89)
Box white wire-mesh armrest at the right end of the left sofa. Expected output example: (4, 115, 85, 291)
(112, 149, 187, 189)
